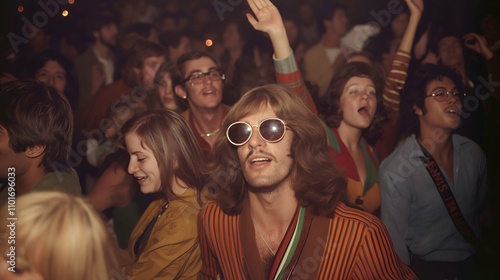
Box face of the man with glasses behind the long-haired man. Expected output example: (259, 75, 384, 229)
(175, 57, 223, 111)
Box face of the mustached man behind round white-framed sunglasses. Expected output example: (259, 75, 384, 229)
(237, 105, 293, 189)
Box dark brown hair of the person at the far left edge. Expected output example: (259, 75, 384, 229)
(0, 79, 73, 172)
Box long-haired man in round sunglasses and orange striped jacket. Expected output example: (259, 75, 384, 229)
(198, 84, 416, 279)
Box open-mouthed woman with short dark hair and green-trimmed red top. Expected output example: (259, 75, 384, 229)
(324, 62, 383, 214)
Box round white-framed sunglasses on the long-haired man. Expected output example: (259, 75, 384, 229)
(226, 118, 287, 146)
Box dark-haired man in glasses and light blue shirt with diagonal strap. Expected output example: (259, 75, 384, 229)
(380, 64, 486, 279)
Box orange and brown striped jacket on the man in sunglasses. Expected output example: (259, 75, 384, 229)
(198, 202, 417, 279)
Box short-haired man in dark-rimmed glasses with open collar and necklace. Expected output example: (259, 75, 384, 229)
(173, 52, 229, 161)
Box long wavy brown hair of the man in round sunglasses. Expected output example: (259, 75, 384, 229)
(205, 84, 346, 217)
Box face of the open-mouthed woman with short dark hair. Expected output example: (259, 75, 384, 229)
(339, 77, 377, 129)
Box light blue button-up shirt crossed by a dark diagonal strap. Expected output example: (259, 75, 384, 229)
(379, 134, 487, 265)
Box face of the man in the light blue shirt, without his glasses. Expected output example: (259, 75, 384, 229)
(414, 77, 462, 134)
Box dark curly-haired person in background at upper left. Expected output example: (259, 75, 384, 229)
(26, 50, 78, 110)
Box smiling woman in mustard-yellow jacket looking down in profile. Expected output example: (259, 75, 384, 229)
(122, 109, 205, 279)
